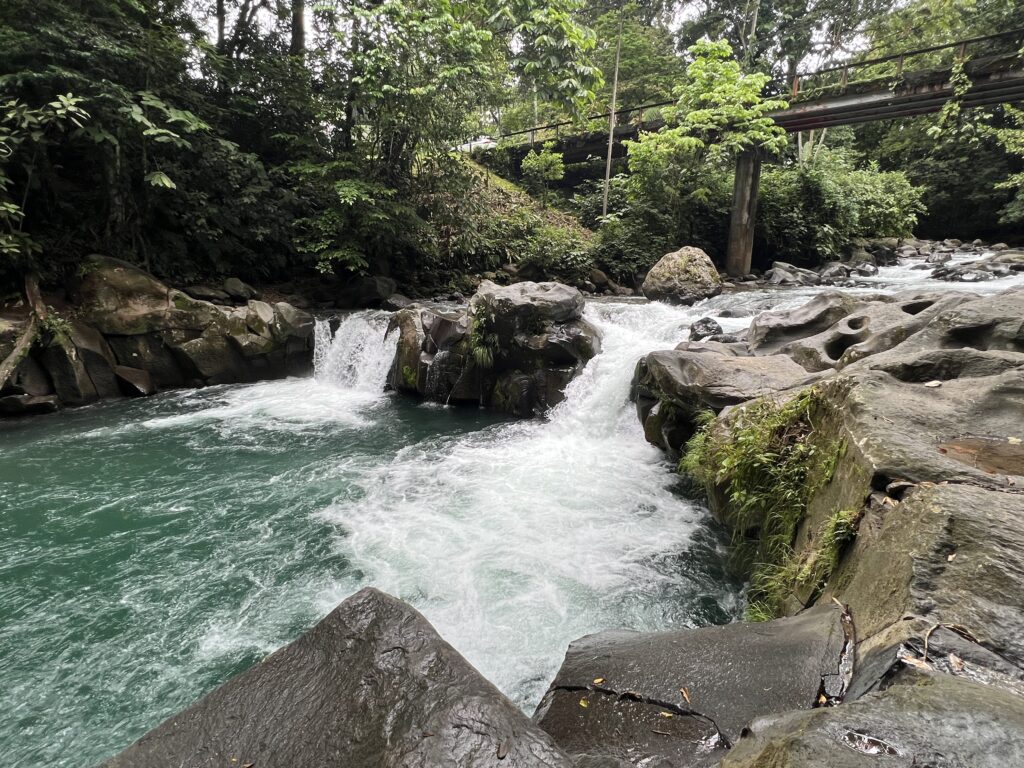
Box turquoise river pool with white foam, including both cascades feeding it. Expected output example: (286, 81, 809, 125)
(0, 304, 737, 767)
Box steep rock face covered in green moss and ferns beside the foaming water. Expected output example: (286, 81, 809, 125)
(680, 381, 870, 620)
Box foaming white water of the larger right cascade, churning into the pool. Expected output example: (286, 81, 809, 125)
(307, 302, 735, 706)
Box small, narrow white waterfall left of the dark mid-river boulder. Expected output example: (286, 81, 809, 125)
(313, 311, 397, 393)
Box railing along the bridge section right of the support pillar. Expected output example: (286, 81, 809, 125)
(790, 28, 1024, 103)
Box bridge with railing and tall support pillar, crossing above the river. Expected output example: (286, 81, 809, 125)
(477, 29, 1024, 275)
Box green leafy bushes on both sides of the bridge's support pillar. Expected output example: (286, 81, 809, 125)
(573, 148, 924, 283)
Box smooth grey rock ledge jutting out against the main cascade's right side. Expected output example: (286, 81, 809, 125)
(630, 349, 809, 453)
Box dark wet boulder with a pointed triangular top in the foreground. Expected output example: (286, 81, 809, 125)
(104, 589, 571, 768)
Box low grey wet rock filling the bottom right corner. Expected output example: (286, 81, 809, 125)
(721, 672, 1024, 768)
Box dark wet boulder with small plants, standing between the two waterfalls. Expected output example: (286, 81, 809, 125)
(388, 281, 600, 417)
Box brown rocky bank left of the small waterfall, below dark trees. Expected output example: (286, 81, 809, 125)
(0, 256, 313, 416)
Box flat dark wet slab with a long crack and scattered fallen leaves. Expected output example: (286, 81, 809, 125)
(535, 606, 847, 768)
